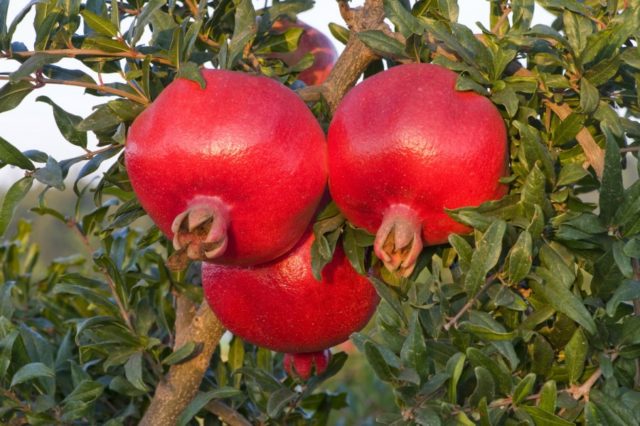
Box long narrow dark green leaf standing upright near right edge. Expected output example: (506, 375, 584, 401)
(599, 127, 624, 225)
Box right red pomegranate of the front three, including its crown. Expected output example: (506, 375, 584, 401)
(328, 64, 507, 276)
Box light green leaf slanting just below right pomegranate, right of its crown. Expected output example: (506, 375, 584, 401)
(464, 220, 507, 296)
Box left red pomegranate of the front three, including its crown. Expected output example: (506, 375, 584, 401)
(125, 70, 327, 265)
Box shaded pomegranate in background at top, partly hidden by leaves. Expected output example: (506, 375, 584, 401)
(270, 19, 338, 86)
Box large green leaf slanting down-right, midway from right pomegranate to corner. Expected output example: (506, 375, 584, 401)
(529, 267, 596, 334)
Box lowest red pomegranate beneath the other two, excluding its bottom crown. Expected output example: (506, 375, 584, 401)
(202, 232, 379, 353)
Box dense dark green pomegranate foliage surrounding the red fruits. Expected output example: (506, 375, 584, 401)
(0, 0, 640, 425)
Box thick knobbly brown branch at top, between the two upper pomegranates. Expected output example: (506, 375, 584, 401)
(298, 0, 387, 112)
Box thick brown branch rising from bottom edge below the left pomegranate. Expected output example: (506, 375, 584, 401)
(140, 294, 224, 426)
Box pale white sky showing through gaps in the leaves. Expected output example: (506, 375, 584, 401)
(0, 0, 552, 187)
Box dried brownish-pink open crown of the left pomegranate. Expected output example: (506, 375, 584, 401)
(171, 196, 229, 266)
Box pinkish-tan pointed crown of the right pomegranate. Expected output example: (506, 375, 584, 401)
(373, 204, 423, 277)
